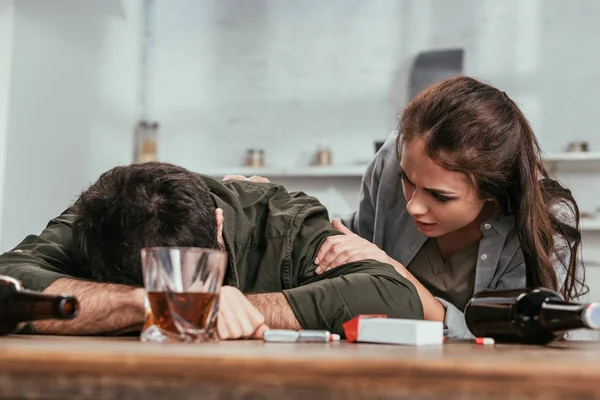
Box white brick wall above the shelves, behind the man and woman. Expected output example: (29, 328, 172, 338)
(153, 0, 600, 161)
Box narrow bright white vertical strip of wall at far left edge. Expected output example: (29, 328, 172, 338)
(0, 0, 15, 247)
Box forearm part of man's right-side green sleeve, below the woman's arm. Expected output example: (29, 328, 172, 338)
(283, 261, 423, 337)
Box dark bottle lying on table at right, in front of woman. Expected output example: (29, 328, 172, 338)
(465, 288, 600, 344)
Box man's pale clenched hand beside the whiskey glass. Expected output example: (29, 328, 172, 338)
(217, 286, 269, 340)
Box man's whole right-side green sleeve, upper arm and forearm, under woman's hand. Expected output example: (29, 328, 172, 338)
(283, 194, 423, 335)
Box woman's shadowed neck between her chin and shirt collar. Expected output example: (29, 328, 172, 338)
(435, 201, 498, 261)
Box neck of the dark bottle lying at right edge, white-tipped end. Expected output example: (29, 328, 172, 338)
(539, 300, 600, 332)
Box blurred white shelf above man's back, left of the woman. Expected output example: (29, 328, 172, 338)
(206, 165, 367, 178)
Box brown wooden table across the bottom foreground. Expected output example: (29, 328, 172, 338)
(0, 336, 600, 400)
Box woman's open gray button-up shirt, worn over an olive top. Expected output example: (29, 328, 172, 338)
(343, 132, 564, 338)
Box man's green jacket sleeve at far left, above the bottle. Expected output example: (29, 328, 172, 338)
(0, 211, 83, 291)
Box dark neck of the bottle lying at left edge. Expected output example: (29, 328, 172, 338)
(0, 290, 79, 322)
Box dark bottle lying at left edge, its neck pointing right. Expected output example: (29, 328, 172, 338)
(0, 275, 79, 335)
